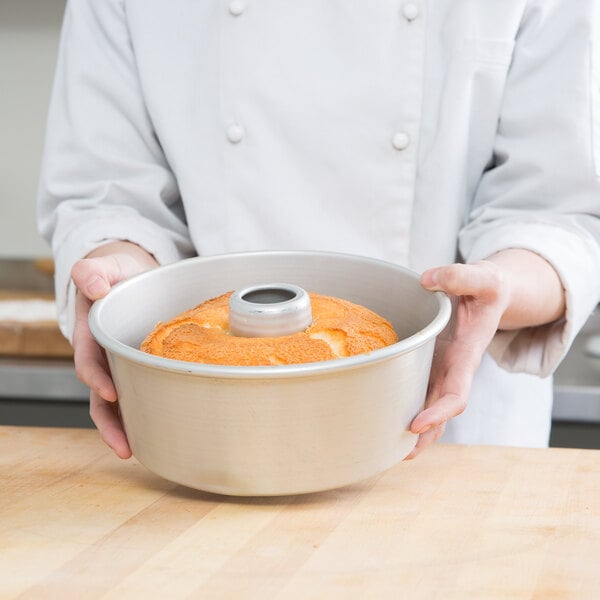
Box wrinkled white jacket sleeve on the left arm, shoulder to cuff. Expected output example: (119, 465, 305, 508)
(38, 0, 193, 339)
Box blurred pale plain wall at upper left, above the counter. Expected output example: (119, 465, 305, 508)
(0, 0, 65, 258)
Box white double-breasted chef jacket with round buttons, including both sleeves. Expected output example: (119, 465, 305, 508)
(39, 0, 600, 446)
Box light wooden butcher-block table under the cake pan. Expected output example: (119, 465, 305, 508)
(0, 427, 600, 600)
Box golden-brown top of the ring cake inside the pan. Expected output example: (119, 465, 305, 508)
(141, 292, 398, 366)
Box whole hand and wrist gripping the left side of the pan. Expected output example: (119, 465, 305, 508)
(71, 242, 158, 458)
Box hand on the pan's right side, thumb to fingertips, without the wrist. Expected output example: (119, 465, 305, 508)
(406, 260, 509, 459)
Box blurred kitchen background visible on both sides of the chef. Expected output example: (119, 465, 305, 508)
(0, 0, 600, 448)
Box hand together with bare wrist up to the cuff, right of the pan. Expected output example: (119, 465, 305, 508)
(407, 248, 565, 459)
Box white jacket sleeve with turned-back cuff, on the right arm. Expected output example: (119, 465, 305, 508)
(459, 0, 600, 376)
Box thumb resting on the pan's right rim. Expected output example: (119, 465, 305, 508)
(421, 261, 504, 299)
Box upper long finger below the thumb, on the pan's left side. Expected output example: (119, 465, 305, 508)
(73, 294, 117, 402)
